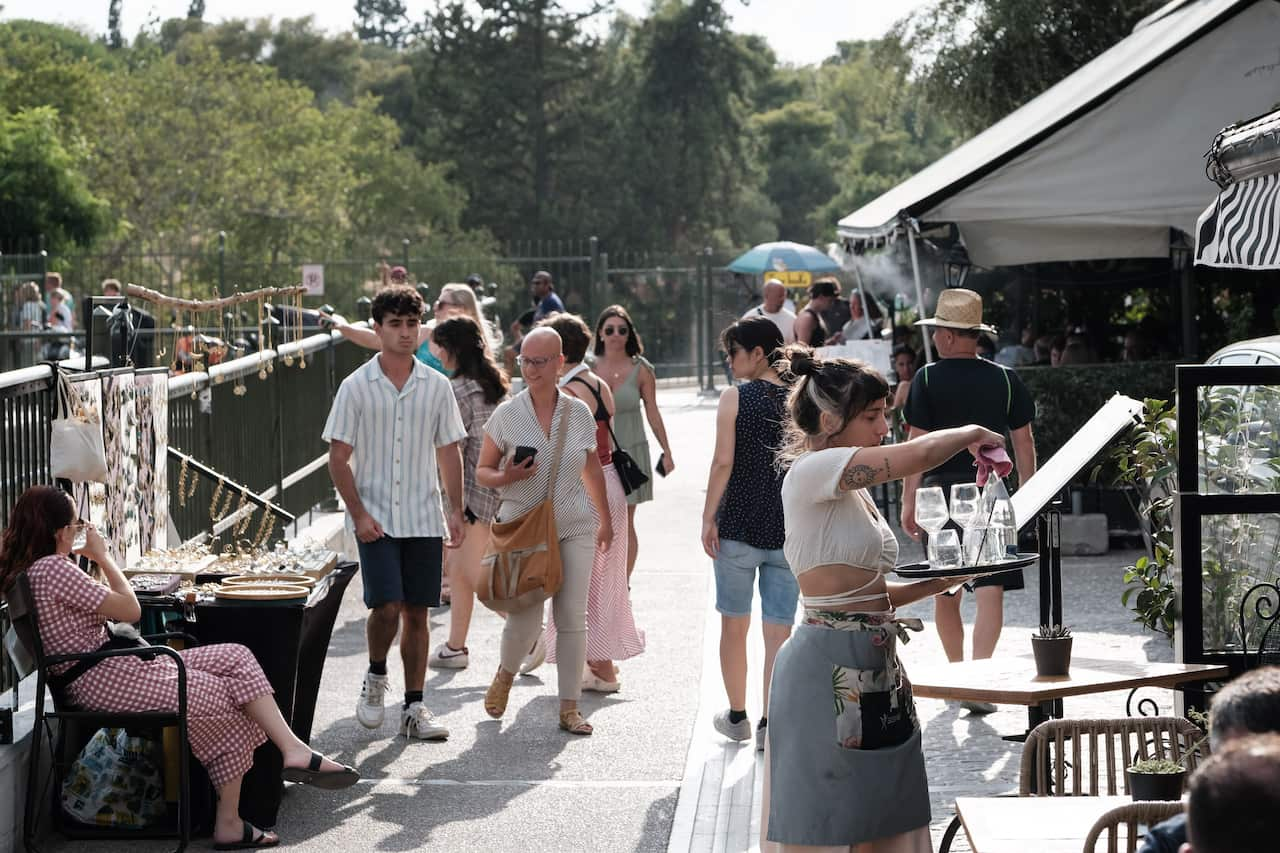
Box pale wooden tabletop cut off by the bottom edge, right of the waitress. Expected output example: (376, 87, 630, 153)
(956, 797, 1133, 853)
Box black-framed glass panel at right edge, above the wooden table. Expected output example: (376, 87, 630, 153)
(1171, 365, 1280, 674)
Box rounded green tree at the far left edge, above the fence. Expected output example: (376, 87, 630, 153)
(0, 106, 106, 251)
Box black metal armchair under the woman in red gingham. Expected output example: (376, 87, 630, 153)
(5, 573, 196, 853)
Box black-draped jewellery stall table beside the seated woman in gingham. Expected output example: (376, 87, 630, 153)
(142, 562, 358, 827)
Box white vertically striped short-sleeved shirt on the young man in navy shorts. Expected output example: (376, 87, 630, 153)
(323, 355, 467, 539)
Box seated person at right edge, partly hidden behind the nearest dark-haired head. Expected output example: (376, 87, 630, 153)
(1138, 666, 1280, 853)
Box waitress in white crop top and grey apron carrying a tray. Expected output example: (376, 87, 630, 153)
(760, 346, 1005, 853)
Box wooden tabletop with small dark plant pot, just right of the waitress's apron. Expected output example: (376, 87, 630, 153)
(906, 654, 1229, 729)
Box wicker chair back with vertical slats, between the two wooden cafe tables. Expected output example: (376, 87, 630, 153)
(1019, 717, 1207, 797)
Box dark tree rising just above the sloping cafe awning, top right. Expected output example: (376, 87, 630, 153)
(896, 0, 1166, 134)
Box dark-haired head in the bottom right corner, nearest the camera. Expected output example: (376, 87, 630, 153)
(1181, 734, 1280, 853)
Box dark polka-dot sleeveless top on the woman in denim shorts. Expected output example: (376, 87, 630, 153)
(718, 379, 788, 551)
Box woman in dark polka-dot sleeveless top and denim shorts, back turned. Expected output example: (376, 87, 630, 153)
(703, 316, 799, 749)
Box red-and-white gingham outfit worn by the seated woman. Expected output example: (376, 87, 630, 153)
(27, 555, 273, 788)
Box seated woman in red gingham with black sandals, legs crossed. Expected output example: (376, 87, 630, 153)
(0, 485, 360, 849)
